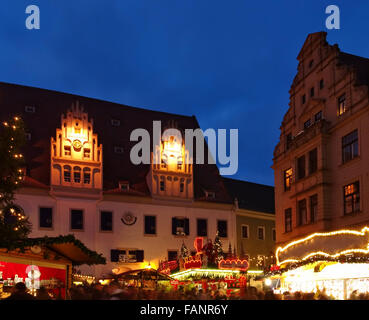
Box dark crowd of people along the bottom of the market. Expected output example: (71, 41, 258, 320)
(5, 281, 369, 300)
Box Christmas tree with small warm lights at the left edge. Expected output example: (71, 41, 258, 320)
(0, 117, 31, 246)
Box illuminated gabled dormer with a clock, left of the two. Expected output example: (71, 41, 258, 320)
(50, 101, 102, 198)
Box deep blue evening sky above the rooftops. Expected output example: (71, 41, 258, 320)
(0, 0, 369, 184)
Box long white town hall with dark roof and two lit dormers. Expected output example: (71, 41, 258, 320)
(0, 83, 274, 277)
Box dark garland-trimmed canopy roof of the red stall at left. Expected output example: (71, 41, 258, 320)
(0, 235, 106, 265)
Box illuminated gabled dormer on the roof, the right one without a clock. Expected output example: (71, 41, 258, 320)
(147, 124, 193, 200)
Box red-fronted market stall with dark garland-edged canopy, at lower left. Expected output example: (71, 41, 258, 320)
(0, 235, 105, 299)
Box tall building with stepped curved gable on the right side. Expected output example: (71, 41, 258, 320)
(273, 32, 369, 244)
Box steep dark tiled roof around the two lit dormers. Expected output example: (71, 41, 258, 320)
(0, 82, 231, 202)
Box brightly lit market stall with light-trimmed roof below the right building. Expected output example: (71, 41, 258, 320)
(270, 227, 369, 300)
